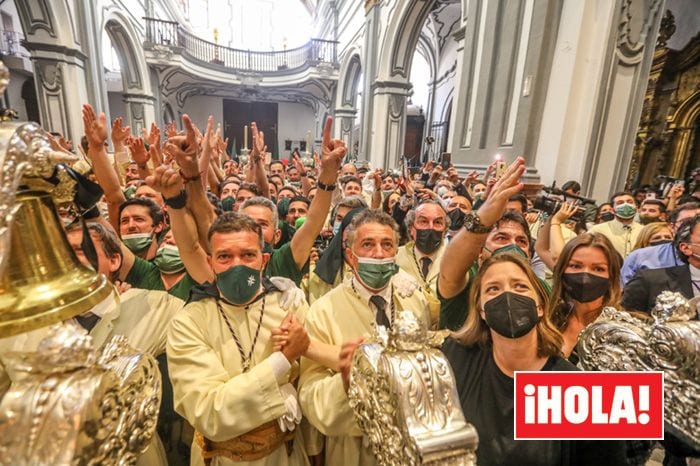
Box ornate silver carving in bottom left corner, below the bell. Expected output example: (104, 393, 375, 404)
(0, 323, 161, 466)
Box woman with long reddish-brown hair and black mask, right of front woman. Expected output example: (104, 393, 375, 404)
(547, 233, 622, 358)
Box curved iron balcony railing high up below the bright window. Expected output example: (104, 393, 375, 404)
(144, 18, 338, 73)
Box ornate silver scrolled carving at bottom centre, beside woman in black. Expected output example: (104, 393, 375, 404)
(348, 311, 478, 466)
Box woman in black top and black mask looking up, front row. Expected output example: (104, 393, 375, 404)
(443, 253, 625, 466)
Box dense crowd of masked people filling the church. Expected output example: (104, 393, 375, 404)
(34, 105, 700, 466)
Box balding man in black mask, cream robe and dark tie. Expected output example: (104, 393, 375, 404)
(396, 200, 450, 321)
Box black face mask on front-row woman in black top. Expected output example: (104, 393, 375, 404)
(484, 291, 540, 338)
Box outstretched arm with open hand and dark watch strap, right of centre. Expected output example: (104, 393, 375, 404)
(438, 157, 525, 298)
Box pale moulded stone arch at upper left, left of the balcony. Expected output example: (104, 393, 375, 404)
(100, 9, 155, 134)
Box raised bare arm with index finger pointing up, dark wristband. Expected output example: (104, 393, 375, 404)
(291, 117, 347, 269)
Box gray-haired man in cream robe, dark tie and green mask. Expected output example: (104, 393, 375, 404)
(299, 210, 430, 466)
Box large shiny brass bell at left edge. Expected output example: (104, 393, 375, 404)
(0, 123, 113, 338)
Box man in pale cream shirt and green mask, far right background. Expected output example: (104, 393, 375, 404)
(588, 192, 643, 259)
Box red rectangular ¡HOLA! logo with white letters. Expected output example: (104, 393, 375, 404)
(514, 371, 664, 440)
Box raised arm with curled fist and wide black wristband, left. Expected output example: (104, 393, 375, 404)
(146, 165, 215, 283)
